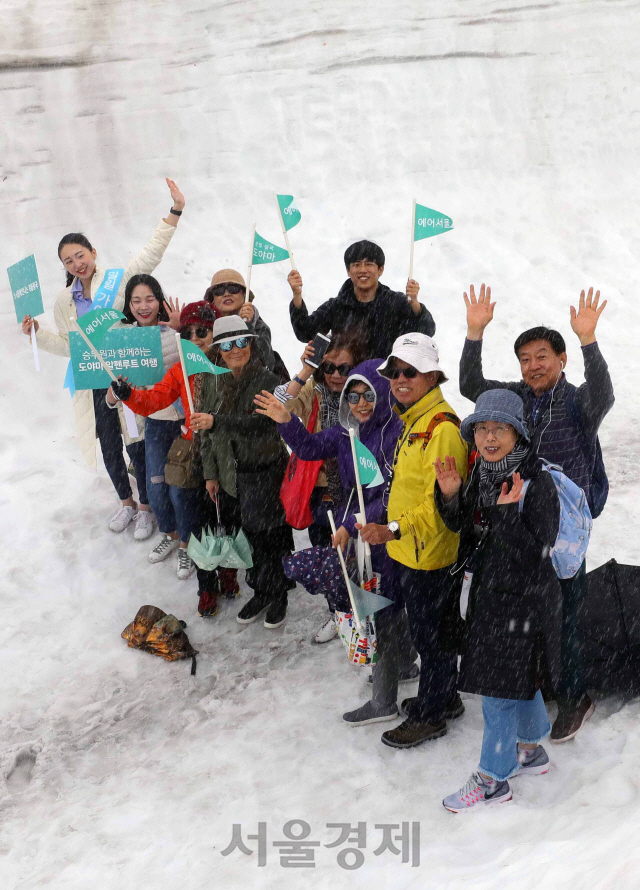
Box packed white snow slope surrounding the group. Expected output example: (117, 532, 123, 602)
(0, 0, 640, 890)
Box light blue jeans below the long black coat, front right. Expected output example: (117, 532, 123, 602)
(478, 689, 551, 782)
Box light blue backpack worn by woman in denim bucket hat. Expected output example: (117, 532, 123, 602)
(519, 458, 593, 579)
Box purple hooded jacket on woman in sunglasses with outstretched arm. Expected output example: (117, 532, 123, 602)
(278, 359, 402, 540)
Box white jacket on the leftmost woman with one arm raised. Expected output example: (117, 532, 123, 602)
(36, 220, 176, 469)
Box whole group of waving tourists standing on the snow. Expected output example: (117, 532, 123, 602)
(23, 181, 614, 812)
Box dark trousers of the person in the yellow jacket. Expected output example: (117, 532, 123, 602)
(397, 563, 457, 724)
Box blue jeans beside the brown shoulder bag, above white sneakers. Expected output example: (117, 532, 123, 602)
(144, 417, 198, 541)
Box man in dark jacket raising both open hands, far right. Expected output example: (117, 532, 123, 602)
(460, 284, 614, 743)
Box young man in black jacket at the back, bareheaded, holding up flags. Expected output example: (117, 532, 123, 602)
(288, 241, 436, 358)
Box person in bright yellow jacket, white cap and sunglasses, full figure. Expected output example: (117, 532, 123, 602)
(361, 333, 468, 748)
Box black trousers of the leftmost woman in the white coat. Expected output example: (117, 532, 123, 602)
(93, 389, 149, 504)
